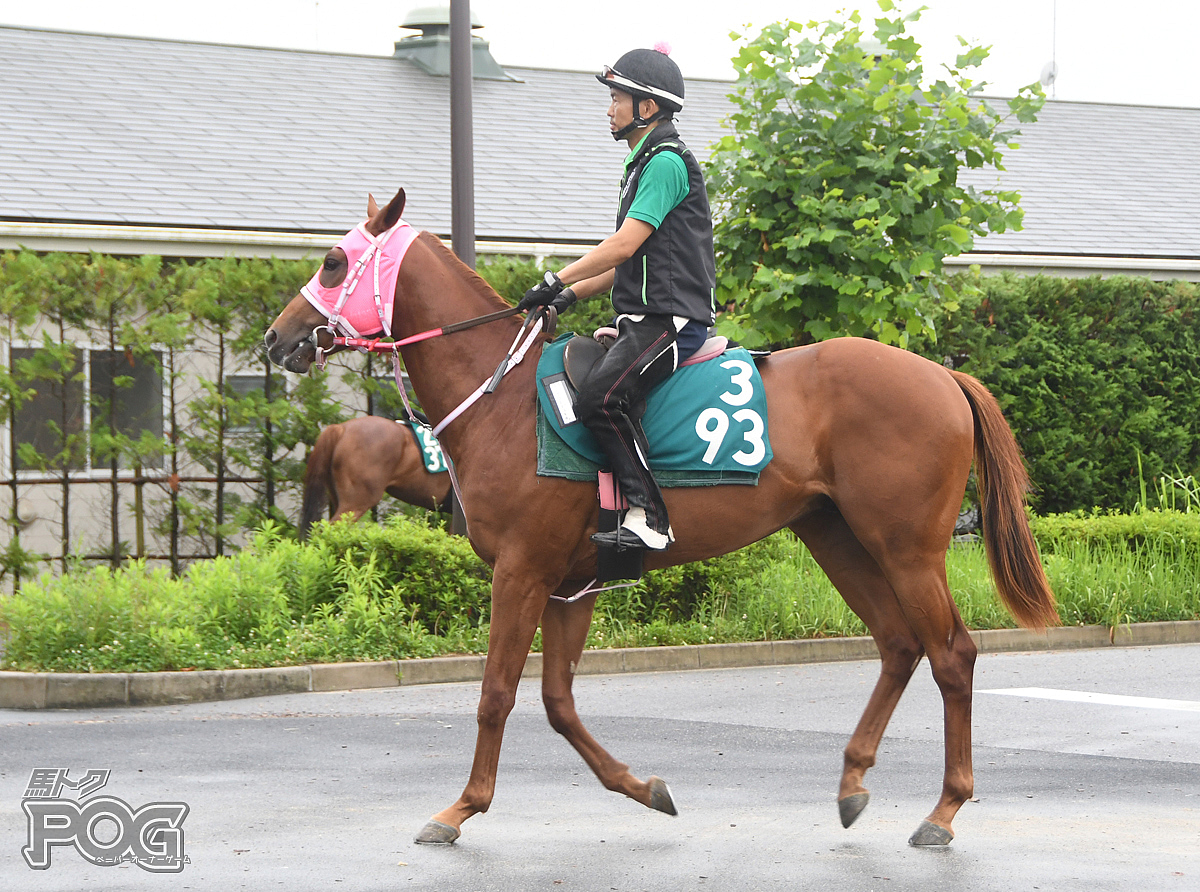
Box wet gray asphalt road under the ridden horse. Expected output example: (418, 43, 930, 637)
(0, 645, 1200, 892)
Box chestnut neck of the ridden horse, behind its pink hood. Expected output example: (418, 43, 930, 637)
(392, 240, 523, 445)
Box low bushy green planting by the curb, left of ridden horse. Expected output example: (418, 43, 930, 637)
(0, 515, 491, 672)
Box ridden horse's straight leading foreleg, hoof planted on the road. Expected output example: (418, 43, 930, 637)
(415, 562, 553, 845)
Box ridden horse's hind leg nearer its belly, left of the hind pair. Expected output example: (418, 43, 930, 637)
(792, 509, 924, 827)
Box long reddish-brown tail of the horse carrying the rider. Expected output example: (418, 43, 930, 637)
(950, 371, 1062, 629)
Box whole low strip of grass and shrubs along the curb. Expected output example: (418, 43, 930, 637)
(0, 511, 1200, 672)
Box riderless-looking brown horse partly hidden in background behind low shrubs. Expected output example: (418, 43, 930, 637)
(300, 415, 450, 539)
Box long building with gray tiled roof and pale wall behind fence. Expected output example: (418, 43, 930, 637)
(0, 19, 1200, 564)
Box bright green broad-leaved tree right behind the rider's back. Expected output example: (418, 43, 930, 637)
(708, 0, 1044, 346)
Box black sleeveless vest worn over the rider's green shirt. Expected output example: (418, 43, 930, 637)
(612, 121, 716, 325)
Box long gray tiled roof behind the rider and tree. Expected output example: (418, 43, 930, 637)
(0, 28, 1200, 257)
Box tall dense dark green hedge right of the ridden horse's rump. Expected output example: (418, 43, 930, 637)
(916, 275, 1200, 514)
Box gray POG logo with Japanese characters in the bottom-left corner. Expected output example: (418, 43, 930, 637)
(20, 768, 190, 873)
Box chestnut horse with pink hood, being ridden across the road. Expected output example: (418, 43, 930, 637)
(265, 190, 1058, 845)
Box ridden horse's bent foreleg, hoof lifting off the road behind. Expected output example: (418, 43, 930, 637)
(541, 594, 676, 815)
